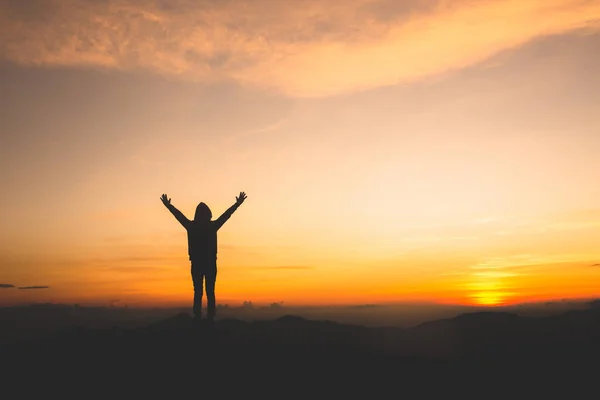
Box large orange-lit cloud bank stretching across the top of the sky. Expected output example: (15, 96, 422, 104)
(0, 0, 600, 96)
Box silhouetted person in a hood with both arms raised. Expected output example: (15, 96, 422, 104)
(160, 192, 246, 322)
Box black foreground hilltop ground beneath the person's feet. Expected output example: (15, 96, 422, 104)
(0, 302, 600, 398)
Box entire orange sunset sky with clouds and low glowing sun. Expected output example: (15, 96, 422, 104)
(0, 0, 600, 307)
